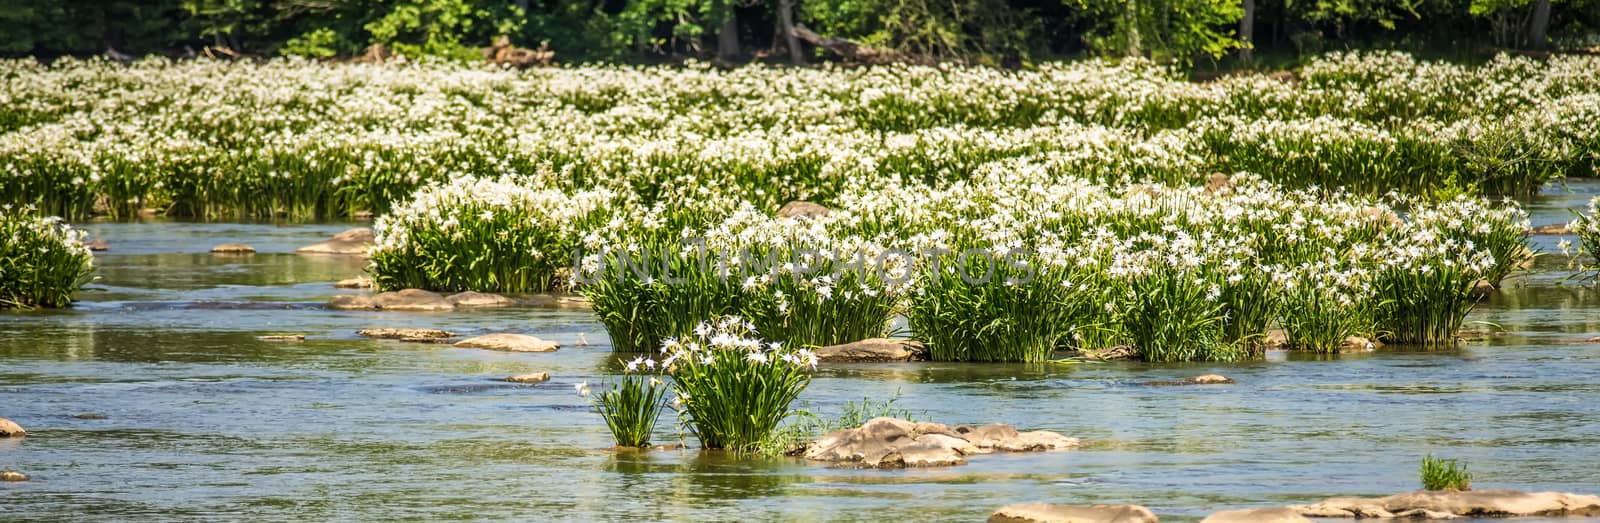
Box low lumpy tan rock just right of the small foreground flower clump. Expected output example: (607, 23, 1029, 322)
(805, 417, 1080, 469)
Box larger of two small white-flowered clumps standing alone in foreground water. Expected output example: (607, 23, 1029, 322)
(662, 317, 816, 451)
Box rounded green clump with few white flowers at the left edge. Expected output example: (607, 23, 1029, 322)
(0, 206, 94, 309)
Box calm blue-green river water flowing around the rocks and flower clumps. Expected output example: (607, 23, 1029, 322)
(9, 184, 1600, 521)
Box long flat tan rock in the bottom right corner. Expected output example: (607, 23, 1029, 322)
(1288, 489, 1600, 520)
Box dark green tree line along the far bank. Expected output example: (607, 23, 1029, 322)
(0, 0, 1600, 66)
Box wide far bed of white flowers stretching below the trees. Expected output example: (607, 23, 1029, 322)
(0, 53, 1600, 214)
